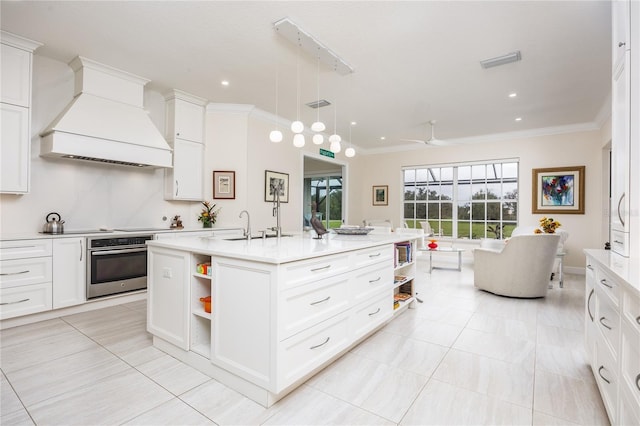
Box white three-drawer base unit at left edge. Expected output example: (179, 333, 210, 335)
(0, 239, 52, 319)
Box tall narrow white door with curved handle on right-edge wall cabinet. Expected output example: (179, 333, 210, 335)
(611, 52, 631, 238)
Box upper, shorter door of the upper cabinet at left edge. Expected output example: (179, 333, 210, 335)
(0, 44, 31, 107)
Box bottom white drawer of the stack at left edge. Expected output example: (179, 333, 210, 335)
(0, 282, 52, 319)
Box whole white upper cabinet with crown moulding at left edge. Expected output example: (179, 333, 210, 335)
(0, 31, 41, 194)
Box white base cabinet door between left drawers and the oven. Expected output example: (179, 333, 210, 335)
(53, 238, 87, 309)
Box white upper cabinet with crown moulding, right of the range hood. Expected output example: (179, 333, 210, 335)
(164, 90, 207, 201)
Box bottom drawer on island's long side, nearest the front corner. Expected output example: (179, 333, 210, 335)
(278, 313, 351, 390)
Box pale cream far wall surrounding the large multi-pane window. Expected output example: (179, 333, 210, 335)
(350, 130, 607, 267)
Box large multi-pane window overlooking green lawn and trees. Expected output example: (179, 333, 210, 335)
(403, 160, 518, 239)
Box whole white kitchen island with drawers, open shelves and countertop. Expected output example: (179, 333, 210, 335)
(147, 232, 418, 407)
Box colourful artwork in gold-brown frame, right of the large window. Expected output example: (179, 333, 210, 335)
(531, 166, 584, 214)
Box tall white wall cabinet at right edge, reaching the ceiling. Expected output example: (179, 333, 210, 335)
(610, 0, 640, 256)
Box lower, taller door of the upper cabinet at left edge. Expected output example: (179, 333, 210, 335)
(0, 104, 31, 194)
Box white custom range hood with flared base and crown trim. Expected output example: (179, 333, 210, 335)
(40, 56, 172, 168)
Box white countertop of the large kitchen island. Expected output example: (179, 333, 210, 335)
(147, 232, 418, 264)
